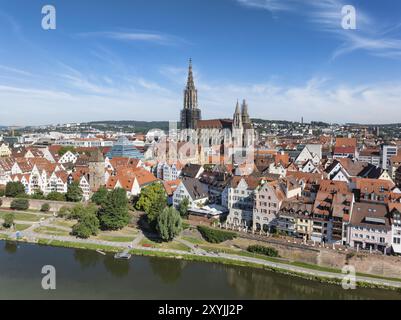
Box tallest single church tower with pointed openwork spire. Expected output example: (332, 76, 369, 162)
(181, 59, 201, 129)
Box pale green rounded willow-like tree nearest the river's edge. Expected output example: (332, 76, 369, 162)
(156, 207, 182, 241)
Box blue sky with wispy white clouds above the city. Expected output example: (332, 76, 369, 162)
(0, 0, 401, 126)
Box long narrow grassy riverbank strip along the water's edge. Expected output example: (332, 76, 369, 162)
(3, 239, 401, 291)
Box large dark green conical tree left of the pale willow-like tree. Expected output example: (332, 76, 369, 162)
(98, 188, 130, 230)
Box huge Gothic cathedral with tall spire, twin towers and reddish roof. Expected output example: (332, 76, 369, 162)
(180, 60, 255, 148)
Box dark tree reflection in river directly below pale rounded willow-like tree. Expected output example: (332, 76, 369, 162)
(149, 257, 187, 283)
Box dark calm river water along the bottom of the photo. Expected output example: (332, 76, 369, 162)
(0, 241, 401, 299)
